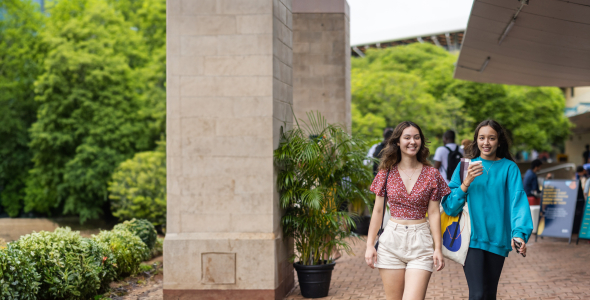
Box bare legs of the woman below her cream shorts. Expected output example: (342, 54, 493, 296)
(379, 269, 432, 300)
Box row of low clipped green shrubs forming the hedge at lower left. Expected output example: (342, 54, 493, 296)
(0, 220, 160, 300)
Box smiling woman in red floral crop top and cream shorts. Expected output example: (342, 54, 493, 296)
(365, 121, 451, 300)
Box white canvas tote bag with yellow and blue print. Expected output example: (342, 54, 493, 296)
(440, 158, 471, 266)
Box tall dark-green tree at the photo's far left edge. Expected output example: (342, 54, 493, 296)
(0, 0, 45, 217)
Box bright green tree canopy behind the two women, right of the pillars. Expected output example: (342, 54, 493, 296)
(351, 43, 571, 152)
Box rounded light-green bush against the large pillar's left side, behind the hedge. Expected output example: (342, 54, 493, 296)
(109, 146, 166, 225)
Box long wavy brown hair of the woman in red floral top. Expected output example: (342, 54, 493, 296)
(379, 121, 431, 170)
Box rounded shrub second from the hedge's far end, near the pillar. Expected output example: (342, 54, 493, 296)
(94, 230, 150, 278)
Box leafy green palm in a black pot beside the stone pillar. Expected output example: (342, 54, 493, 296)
(274, 113, 372, 298)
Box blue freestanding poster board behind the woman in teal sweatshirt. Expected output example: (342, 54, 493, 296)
(535, 179, 580, 243)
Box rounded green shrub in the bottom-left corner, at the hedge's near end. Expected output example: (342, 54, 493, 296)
(0, 244, 41, 300)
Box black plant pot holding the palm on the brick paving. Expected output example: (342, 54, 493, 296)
(293, 261, 336, 298)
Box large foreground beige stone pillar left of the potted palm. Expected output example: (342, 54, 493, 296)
(164, 0, 294, 300)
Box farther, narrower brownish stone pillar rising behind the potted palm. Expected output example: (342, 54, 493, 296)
(293, 0, 352, 132)
